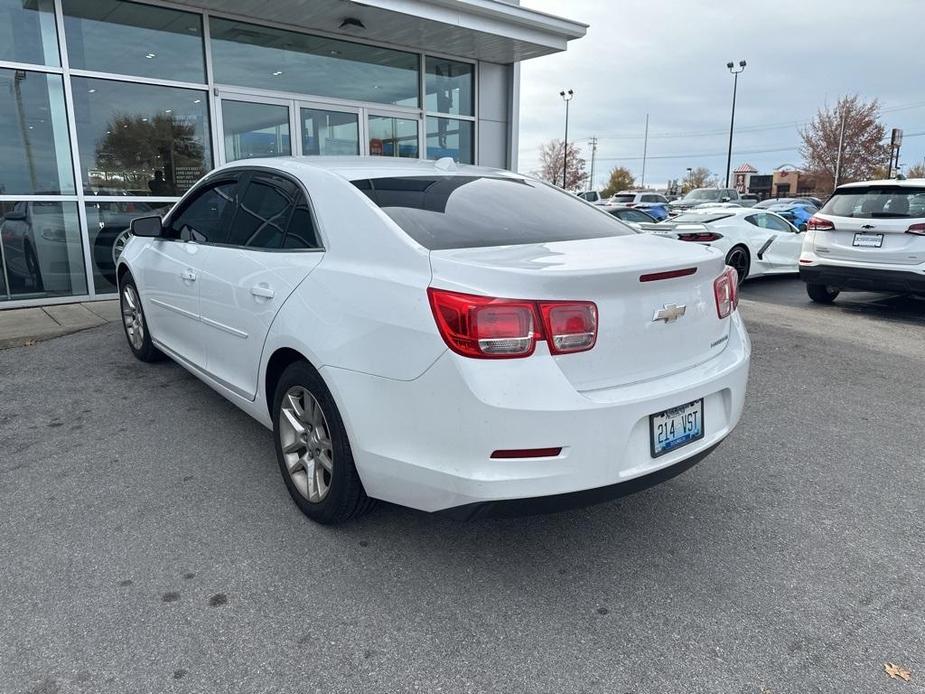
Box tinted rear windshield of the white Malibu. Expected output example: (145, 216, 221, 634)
(353, 176, 635, 251)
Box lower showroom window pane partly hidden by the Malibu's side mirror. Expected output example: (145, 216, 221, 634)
(86, 201, 172, 294)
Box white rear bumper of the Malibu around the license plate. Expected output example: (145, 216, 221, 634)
(321, 313, 751, 517)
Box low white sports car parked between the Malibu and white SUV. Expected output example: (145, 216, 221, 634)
(641, 206, 804, 283)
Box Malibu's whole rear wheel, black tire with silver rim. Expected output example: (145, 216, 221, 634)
(273, 361, 374, 525)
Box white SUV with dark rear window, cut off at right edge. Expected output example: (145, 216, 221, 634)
(800, 178, 925, 304)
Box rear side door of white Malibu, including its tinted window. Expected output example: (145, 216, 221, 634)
(199, 170, 323, 399)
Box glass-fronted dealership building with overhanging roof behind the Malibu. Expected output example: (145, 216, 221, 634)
(0, 0, 587, 309)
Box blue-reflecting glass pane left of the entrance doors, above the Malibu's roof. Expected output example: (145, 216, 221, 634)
(222, 100, 292, 161)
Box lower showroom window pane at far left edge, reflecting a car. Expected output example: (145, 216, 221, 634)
(0, 200, 87, 301)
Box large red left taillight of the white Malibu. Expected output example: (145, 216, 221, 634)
(427, 287, 597, 359)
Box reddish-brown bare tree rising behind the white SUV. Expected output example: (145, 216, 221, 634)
(800, 94, 890, 190)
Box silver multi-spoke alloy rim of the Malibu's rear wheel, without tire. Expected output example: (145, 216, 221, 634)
(279, 386, 334, 503)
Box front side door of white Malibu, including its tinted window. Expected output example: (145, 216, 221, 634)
(143, 176, 237, 366)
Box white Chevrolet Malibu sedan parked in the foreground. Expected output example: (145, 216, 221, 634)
(117, 157, 751, 523)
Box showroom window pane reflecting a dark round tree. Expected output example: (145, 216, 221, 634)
(71, 77, 212, 197)
